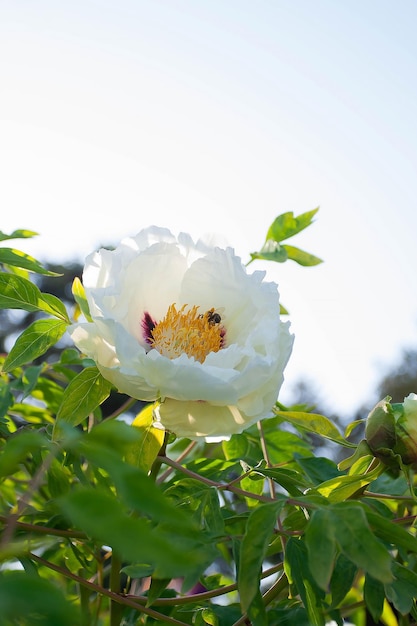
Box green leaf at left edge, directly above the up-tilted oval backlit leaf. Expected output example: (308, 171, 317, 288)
(0, 272, 69, 321)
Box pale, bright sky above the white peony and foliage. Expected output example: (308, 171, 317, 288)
(0, 0, 417, 415)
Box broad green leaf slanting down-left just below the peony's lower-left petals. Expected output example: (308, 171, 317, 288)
(54, 367, 112, 439)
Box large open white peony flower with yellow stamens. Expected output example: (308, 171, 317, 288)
(70, 227, 293, 438)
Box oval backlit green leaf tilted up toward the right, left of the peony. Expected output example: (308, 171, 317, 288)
(3, 319, 67, 372)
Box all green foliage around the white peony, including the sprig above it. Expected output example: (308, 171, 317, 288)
(0, 209, 417, 626)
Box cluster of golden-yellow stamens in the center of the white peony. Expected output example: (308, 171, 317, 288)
(149, 304, 225, 363)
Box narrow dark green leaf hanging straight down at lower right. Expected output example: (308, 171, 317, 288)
(305, 508, 337, 591)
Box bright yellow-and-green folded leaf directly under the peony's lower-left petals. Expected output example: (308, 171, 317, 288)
(126, 404, 165, 472)
